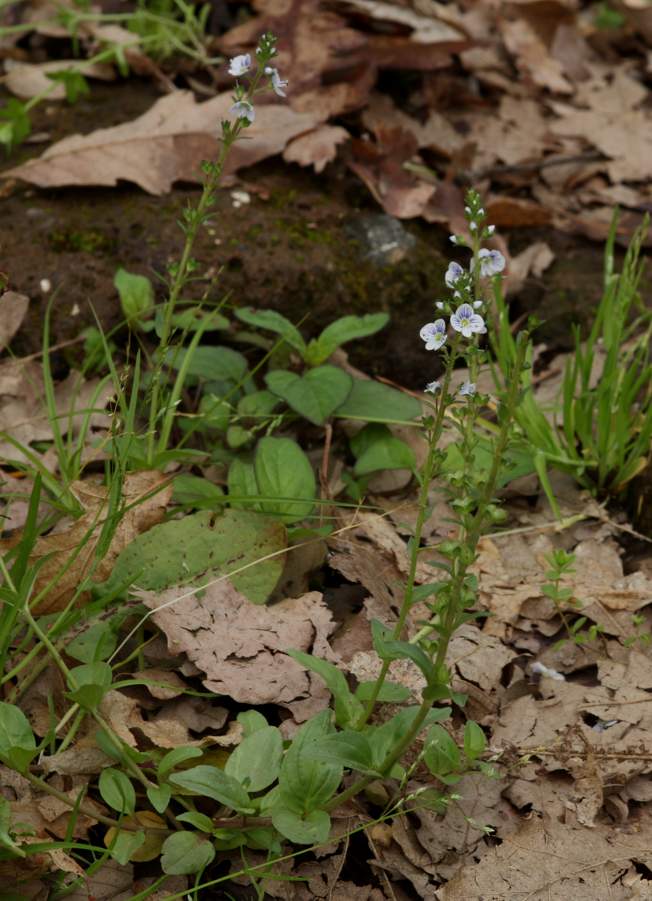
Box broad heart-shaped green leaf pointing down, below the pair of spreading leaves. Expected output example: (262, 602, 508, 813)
(265, 366, 353, 425)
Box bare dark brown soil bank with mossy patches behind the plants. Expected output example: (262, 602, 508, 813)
(0, 79, 602, 389)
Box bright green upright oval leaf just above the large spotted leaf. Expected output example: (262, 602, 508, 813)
(254, 438, 316, 522)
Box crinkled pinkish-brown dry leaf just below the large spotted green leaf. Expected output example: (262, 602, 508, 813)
(138, 579, 342, 722)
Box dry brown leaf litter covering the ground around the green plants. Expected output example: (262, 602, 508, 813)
(0, 0, 652, 901)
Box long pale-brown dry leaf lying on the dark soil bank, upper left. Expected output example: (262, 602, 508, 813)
(3, 91, 319, 194)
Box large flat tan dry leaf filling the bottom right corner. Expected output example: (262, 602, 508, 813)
(437, 817, 652, 901)
